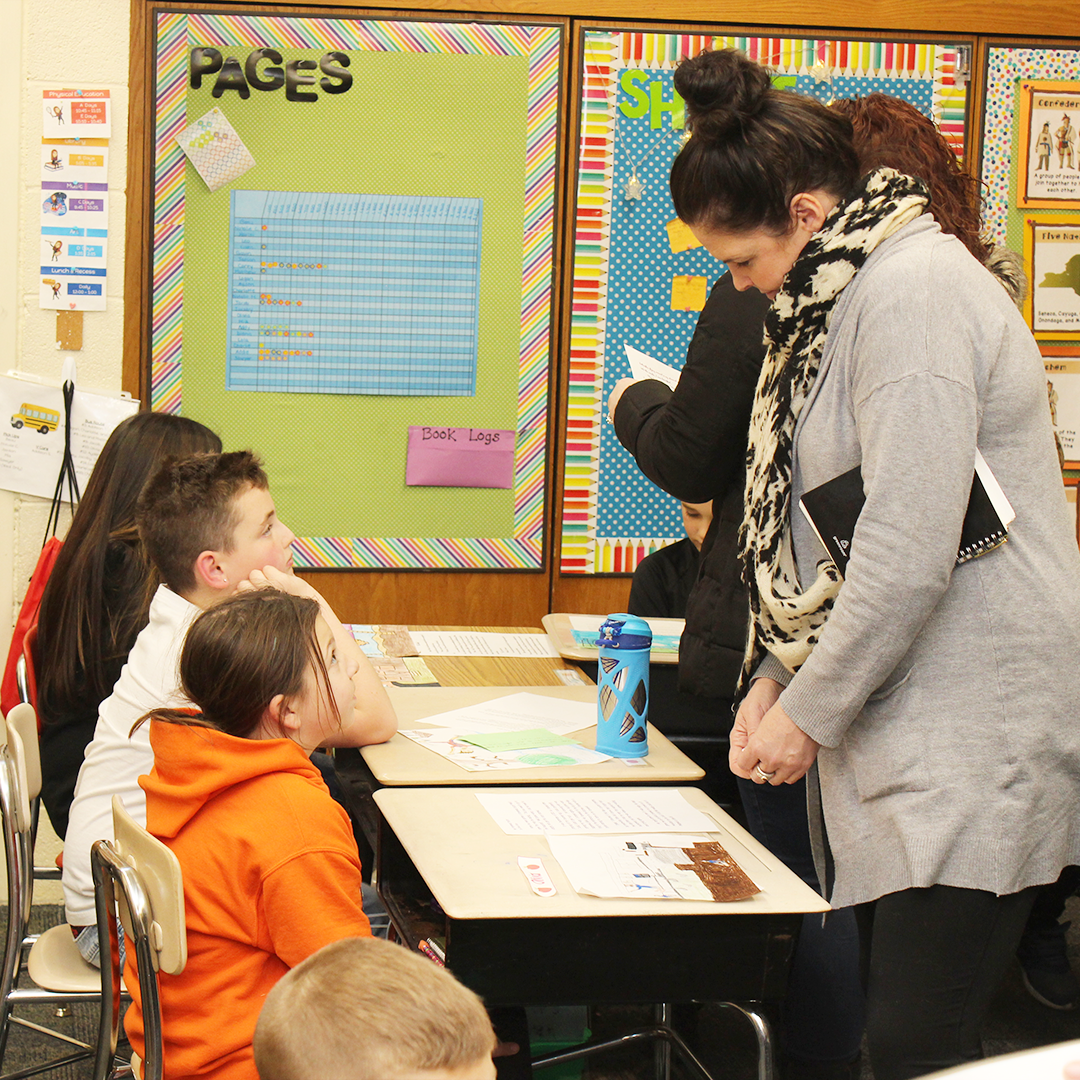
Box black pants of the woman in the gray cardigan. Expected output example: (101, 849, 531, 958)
(855, 885, 1037, 1080)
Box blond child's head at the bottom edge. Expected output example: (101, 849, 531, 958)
(255, 937, 495, 1080)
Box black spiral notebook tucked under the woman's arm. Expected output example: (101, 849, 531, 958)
(799, 450, 1016, 575)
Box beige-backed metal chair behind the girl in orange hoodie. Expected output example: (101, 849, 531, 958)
(94, 795, 188, 1080)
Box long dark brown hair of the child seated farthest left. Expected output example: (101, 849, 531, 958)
(37, 413, 221, 721)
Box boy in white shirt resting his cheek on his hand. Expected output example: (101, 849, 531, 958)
(64, 450, 396, 963)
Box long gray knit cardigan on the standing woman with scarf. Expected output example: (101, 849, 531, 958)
(759, 215, 1080, 906)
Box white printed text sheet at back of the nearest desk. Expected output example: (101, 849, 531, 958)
(476, 787, 717, 835)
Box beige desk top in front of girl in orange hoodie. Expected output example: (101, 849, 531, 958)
(375, 787, 829, 919)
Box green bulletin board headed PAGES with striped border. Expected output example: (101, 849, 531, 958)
(150, 11, 565, 570)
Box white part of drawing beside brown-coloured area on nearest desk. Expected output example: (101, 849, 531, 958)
(546, 833, 714, 901)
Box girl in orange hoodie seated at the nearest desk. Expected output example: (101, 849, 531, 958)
(124, 589, 370, 1080)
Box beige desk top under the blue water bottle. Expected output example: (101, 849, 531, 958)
(361, 686, 705, 786)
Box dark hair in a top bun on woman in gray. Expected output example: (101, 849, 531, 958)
(671, 49, 860, 235)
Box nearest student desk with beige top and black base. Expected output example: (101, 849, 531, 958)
(375, 787, 828, 1077)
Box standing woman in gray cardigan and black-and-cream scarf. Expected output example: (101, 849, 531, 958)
(672, 51, 1080, 1080)
